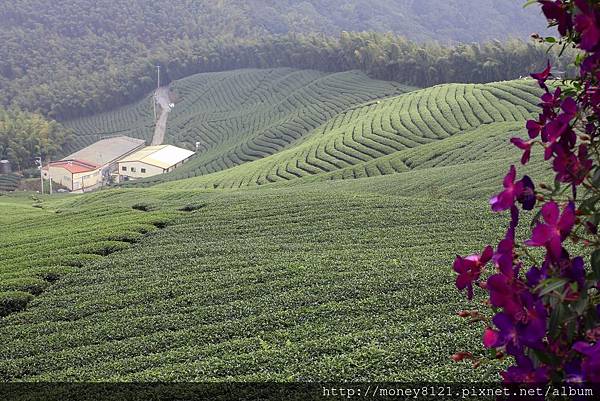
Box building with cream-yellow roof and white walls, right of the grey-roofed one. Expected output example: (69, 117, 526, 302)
(119, 145, 195, 181)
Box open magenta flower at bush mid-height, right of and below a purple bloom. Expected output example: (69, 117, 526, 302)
(525, 202, 575, 259)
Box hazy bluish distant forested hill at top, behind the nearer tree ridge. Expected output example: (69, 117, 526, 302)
(241, 0, 545, 42)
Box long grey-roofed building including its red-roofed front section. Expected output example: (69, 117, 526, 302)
(42, 136, 146, 192)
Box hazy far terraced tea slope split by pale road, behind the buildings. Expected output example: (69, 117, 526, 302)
(64, 68, 412, 165)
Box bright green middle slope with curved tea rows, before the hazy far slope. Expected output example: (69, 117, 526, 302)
(151, 80, 540, 188)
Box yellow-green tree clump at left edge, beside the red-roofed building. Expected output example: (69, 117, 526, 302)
(0, 109, 71, 170)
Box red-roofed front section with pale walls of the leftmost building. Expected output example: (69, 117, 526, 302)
(43, 160, 102, 192)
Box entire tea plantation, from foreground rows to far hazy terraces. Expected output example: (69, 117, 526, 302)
(0, 69, 548, 382)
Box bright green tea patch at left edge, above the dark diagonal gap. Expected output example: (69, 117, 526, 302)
(0, 195, 177, 316)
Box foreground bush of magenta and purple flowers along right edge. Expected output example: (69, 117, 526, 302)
(454, 0, 600, 383)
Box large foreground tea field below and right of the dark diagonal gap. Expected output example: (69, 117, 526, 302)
(0, 174, 510, 381)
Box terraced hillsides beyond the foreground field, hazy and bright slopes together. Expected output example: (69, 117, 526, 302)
(65, 69, 540, 188)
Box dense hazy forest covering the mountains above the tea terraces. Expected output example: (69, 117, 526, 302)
(0, 0, 546, 119)
